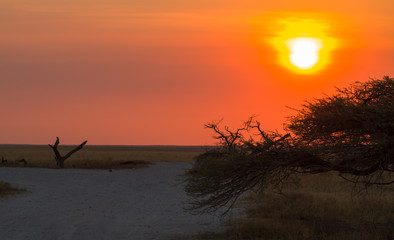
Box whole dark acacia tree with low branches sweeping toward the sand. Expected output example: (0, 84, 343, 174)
(185, 77, 394, 213)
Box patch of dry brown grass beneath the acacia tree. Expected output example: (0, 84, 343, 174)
(201, 174, 394, 240)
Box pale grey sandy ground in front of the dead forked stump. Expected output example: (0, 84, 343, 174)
(0, 163, 225, 240)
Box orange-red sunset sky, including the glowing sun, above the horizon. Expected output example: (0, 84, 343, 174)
(0, 0, 394, 145)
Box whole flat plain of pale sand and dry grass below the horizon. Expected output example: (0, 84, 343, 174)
(0, 145, 394, 240)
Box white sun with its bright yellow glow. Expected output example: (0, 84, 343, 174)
(271, 18, 337, 74)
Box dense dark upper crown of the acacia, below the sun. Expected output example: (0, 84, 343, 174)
(287, 77, 394, 184)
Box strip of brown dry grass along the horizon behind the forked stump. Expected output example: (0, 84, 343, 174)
(0, 145, 203, 169)
